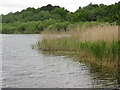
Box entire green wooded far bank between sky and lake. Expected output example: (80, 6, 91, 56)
(0, 2, 120, 34)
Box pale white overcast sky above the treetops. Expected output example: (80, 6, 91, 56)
(0, 0, 119, 14)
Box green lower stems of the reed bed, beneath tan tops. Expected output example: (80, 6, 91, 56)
(38, 37, 120, 60)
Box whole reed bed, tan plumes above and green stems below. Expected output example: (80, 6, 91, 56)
(38, 24, 120, 66)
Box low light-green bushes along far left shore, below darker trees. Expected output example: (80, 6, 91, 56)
(2, 19, 59, 34)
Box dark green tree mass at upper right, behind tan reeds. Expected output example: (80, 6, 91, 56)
(74, 2, 120, 22)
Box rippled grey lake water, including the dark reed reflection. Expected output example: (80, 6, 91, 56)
(0, 34, 119, 88)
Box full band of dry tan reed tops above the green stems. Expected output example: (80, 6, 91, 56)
(41, 24, 118, 41)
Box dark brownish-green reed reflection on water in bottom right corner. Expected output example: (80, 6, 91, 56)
(80, 58, 120, 88)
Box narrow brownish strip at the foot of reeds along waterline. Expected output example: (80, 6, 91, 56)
(39, 50, 119, 68)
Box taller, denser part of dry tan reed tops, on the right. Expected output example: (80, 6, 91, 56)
(70, 25, 118, 41)
